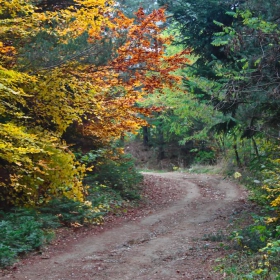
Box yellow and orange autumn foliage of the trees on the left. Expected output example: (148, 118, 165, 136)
(0, 0, 188, 206)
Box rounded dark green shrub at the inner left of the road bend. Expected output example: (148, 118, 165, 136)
(77, 147, 143, 200)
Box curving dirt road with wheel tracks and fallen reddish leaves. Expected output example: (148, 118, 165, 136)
(0, 172, 246, 280)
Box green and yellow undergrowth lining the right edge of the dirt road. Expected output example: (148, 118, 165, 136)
(213, 165, 280, 280)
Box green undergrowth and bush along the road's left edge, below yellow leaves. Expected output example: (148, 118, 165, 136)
(0, 152, 142, 267)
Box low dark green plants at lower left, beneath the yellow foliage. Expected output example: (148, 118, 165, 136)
(0, 198, 109, 267)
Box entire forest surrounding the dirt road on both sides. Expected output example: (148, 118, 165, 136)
(0, 0, 280, 279)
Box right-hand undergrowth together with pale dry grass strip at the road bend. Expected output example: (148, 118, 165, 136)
(185, 143, 280, 280)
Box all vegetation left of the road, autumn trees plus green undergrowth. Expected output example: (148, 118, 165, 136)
(0, 0, 178, 266)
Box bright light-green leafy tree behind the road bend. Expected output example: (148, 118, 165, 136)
(137, 28, 218, 165)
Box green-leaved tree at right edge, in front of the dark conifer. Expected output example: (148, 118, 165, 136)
(213, 3, 280, 138)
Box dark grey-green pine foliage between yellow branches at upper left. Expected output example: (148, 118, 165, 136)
(20, 30, 115, 72)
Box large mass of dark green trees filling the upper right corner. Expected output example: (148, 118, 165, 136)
(161, 0, 279, 166)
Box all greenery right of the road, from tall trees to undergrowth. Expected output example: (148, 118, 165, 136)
(129, 0, 280, 279)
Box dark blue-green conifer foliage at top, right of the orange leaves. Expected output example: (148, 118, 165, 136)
(159, 0, 234, 63)
